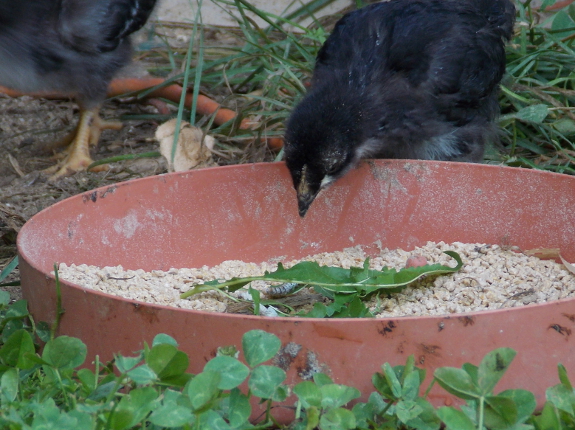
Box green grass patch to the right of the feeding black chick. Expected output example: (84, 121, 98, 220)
(502, 0, 575, 174)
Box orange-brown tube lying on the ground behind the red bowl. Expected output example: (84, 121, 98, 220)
(0, 78, 283, 149)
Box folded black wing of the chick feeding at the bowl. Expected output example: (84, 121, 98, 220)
(388, 0, 515, 127)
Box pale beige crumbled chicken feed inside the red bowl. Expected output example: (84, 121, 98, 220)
(55, 242, 575, 317)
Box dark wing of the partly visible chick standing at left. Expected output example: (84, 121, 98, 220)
(58, 0, 156, 53)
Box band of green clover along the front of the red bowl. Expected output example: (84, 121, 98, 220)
(0, 284, 575, 430)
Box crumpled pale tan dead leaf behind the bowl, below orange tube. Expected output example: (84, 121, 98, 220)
(156, 118, 216, 172)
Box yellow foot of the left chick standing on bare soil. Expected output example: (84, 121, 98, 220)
(44, 108, 122, 180)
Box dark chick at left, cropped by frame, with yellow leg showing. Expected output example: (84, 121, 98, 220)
(0, 0, 156, 177)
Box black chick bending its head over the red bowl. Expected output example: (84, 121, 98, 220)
(285, 0, 515, 217)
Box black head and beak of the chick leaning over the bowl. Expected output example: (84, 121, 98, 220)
(284, 83, 363, 217)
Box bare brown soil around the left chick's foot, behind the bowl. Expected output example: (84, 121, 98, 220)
(0, 65, 273, 300)
